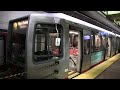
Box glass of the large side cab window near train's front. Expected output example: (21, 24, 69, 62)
(34, 24, 63, 61)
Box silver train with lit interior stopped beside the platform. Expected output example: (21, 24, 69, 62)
(6, 13, 120, 79)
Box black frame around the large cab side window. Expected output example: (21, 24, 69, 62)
(33, 22, 64, 63)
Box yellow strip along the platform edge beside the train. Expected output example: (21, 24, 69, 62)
(73, 54, 120, 79)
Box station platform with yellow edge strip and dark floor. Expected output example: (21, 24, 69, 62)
(68, 53, 120, 79)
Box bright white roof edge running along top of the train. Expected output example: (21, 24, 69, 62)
(11, 13, 120, 37)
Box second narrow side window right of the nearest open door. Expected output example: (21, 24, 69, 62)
(95, 33, 101, 51)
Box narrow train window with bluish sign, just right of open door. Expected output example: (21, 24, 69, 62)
(83, 35, 90, 55)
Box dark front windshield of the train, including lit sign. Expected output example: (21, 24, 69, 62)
(11, 21, 28, 65)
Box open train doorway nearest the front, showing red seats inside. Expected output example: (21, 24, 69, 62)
(69, 30, 81, 72)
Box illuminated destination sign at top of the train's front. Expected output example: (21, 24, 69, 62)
(13, 20, 28, 30)
